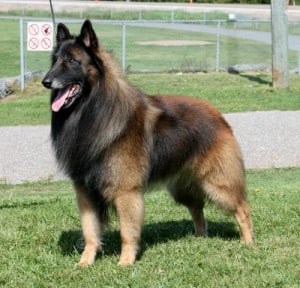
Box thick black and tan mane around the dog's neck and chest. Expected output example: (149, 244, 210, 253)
(52, 24, 147, 180)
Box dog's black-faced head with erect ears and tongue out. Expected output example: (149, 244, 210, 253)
(42, 20, 104, 112)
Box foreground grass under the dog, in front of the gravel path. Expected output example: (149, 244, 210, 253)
(0, 168, 300, 288)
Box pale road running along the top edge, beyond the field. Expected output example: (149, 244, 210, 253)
(0, 0, 300, 20)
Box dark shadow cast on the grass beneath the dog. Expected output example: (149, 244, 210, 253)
(58, 220, 239, 258)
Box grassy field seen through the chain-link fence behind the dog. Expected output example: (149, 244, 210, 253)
(0, 18, 298, 77)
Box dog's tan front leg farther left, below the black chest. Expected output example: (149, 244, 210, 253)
(74, 185, 103, 267)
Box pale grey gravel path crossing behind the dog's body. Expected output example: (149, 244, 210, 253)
(0, 111, 300, 183)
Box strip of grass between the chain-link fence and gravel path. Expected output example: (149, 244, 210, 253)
(0, 73, 300, 126)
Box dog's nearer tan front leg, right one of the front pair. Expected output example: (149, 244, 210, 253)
(114, 190, 144, 265)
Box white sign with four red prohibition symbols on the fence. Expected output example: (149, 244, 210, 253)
(27, 22, 53, 51)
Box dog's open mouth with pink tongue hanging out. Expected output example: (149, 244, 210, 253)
(52, 83, 81, 112)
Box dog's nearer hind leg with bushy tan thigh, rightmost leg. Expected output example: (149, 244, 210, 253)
(194, 138, 253, 243)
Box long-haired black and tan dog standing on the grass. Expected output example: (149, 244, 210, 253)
(42, 20, 253, 266)
